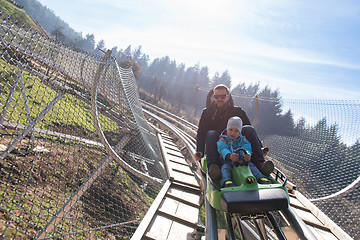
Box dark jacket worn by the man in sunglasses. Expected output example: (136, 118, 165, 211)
(196, 91, 251, 154)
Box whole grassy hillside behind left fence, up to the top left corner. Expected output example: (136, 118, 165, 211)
(0, 11, 158, 239)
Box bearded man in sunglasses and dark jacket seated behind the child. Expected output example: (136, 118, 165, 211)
(195, 84, 274, 180)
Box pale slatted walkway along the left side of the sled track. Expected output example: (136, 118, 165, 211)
(132, 115, 205, 239)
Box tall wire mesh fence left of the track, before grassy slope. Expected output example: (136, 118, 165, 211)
(0, 15, 166, 239)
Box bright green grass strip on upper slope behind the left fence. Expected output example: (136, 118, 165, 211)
(0, 60, 120, 136)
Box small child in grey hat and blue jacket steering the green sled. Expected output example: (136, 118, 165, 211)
(217, 117, 271, 187)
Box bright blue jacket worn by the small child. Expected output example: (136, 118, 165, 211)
(217, 131, 252, 163)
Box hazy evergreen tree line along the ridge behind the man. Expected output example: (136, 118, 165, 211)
(16, 0, 358, 148)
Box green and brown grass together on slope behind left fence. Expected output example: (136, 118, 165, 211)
(0, 56, 159, 239)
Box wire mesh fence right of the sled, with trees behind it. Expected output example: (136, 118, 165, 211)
(229, 96, 360, 239)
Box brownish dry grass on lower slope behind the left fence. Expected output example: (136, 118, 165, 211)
(0, 127, 158, 239)
